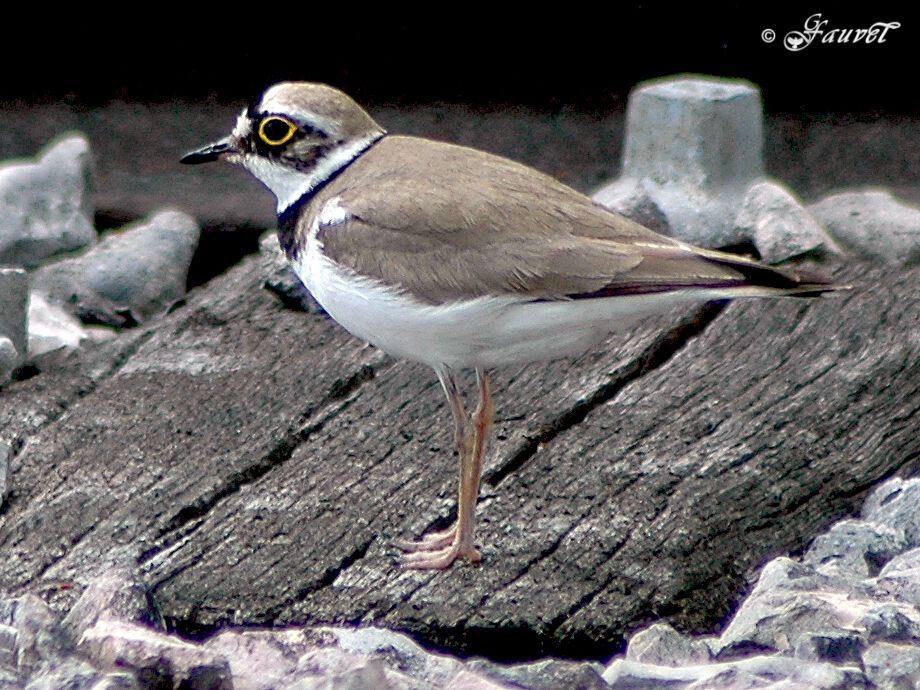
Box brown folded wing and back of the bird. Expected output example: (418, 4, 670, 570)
(310, 136, 832, 303)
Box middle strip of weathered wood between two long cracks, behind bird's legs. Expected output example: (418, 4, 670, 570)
(145, 298, 705, 629)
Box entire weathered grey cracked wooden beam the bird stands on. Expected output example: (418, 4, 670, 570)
(0, 260, 920, 658)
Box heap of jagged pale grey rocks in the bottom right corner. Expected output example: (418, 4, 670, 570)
(604, 470, 920, 688)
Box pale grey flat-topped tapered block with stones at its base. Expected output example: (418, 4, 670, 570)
(593, 76, 836, 262)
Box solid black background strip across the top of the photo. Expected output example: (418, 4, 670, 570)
(0, 0, 920, 113)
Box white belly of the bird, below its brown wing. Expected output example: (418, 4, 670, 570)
(293, 243, 719, 368)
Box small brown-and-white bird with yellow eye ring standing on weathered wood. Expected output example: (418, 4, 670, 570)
(181, 82, 845, 569)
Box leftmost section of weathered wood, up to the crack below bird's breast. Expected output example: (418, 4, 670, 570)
(0, 253, 386, 591)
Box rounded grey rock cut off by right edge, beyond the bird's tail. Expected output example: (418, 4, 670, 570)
(808, 190, 920, 266)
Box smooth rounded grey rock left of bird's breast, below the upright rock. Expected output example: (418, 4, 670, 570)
(32, 210, 201, 326)
